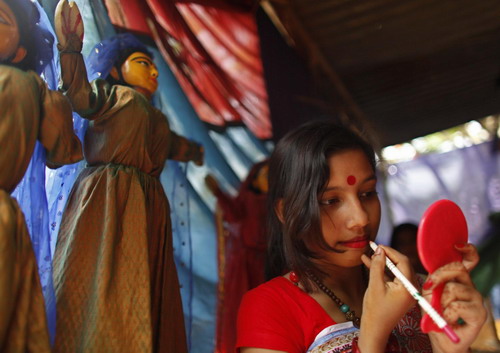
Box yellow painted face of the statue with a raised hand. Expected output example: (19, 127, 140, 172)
(121, 52, 158, 98)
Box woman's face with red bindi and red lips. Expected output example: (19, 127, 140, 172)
(312, 149, 380, 267)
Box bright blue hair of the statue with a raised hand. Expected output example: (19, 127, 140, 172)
(87, 33, 153, 85)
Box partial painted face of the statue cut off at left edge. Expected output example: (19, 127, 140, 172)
(0, 0, 19, 62)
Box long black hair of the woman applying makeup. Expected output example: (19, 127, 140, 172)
(266, 120, 376, 291)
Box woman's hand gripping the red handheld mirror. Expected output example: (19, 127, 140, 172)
(422, 244, 486, 353)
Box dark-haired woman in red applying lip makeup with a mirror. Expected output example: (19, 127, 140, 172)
(237, 120, 486, 353)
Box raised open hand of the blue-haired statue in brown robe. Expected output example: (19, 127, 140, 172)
(54, 0, 83, 52)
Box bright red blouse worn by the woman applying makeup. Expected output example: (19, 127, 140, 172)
(236, 277, 432, 353)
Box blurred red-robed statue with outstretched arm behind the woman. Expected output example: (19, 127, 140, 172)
(205, 160, 268, 353)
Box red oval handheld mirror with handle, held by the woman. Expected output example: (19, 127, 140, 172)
(417, 200, 468, 332)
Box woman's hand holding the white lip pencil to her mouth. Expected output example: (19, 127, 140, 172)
(358, 245, 415, 353)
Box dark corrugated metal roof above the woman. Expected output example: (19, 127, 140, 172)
(264, 0, 500, 145)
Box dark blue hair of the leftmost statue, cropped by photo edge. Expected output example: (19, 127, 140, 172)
(3, 0, 54, 74)
